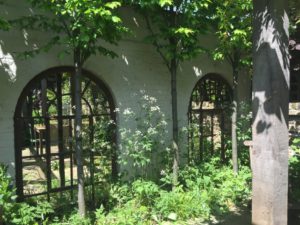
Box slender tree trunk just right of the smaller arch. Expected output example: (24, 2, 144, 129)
(231, 65, 238, 175)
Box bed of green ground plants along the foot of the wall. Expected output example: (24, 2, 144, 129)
(0, 161, 251, 224)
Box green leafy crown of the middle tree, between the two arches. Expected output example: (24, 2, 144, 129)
(129, 0, 211, 69)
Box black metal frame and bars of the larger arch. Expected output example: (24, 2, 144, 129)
(14, 66, 117, 200)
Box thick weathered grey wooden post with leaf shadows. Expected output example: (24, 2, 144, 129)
(251, 0, 289, 225)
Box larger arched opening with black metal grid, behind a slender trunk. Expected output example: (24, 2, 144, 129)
(14, 67, 117, 200)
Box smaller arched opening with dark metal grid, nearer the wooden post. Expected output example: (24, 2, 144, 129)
(188, 74, 232, 162)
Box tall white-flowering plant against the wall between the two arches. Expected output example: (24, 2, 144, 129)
(119, 91, 170, 177)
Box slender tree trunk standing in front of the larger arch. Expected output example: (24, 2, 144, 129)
(74, 50, 85, 217)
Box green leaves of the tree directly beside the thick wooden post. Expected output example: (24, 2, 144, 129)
(213, 0, 253, 68)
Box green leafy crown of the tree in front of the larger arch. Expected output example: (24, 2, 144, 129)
(14, 0, 127, 62)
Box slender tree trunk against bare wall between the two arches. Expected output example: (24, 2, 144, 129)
(170, 59, 179, 188)
